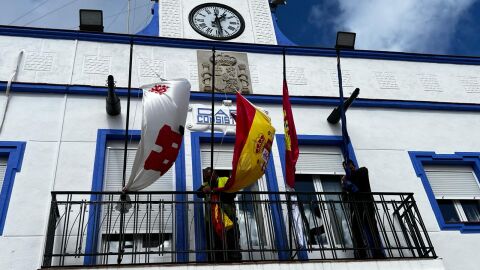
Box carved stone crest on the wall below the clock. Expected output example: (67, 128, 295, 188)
(197, 51, 252, 94)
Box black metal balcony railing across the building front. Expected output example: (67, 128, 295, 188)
(43, 192, 436, 267)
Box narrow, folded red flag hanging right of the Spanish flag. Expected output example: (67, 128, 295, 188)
(283, 79, 299, 188)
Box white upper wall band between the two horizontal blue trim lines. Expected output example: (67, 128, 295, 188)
(0, 36, 480, 103)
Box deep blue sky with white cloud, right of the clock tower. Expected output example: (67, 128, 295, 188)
(277, 0, 480, 56)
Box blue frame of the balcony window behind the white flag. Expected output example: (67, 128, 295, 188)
(84, 129, 188, 265)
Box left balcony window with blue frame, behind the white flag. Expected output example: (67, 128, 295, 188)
(84, 129, 188, 265)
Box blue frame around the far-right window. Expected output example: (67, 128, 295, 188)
(409, 151, 480, 233)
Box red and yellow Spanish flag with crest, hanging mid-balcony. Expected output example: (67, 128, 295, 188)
(223, 93, 275, 192)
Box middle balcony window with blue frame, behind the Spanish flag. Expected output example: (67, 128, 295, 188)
(188, 132, 284, 261)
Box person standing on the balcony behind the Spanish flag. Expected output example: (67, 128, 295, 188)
(197, 167, 242, 261)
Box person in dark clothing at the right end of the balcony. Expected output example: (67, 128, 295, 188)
(342, 160, 385, 259)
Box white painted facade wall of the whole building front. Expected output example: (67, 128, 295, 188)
(0, 37, 480, 269)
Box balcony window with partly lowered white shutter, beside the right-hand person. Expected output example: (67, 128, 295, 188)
(295, 145, 352, 257)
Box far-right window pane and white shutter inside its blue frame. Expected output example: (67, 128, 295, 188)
(424, 165, 480, 223)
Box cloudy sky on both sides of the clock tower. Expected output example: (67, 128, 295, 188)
(0, 0, 480, 56)
